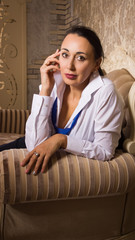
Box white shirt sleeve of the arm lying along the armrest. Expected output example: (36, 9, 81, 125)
(66, 85, 124, 160)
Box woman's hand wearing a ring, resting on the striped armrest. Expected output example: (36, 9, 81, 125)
(21, 134, 67, 175)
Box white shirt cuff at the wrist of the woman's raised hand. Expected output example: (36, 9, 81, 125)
(31, 94, 53, 116)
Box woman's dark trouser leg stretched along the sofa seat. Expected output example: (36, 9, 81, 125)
(0, 136, 26, 152)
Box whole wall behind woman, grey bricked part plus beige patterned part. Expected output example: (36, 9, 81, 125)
(27, 0, 135, 109)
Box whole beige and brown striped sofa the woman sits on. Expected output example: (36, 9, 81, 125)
(0, 69, 135, 240)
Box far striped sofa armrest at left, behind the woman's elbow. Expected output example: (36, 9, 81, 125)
(0, 109, 30, 134)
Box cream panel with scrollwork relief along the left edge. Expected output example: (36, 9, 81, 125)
(0, 0, 26, 109)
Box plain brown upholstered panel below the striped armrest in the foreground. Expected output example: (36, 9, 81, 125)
(2, 195, 127, 240)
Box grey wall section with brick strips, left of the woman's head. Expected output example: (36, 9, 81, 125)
(27, 0, 78, 109)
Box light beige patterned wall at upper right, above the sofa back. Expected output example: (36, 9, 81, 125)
(74, 0, 135, 60)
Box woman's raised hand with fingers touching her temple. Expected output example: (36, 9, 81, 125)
(40, 50, 60, 96)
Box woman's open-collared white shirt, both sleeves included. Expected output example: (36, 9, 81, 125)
(25, 73, 124, 160)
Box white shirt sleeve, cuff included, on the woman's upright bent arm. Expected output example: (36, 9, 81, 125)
(25, 94, 53, 151)
